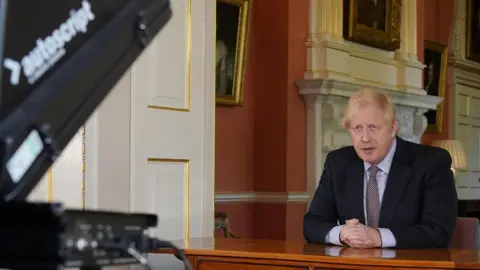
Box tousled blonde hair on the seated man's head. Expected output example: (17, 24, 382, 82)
(342, 88, 395, 129)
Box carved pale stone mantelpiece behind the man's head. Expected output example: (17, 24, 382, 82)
(297, 79, 442, 196)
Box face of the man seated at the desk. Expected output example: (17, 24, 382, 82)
(349, 105, 397, 165)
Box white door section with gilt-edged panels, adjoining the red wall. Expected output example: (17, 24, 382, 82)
(131, 0, 215, 243)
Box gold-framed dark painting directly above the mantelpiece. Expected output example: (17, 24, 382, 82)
(343, 0, 402, 51)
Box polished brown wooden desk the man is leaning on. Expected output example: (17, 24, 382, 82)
(153, 238, 480, 270)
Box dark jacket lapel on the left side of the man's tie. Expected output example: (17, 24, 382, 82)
(345, 156, 365, 224)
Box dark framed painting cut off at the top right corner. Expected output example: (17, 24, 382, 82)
(465, 0, 480, 63)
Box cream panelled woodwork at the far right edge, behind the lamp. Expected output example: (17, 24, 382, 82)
(449, 0, 480, 200)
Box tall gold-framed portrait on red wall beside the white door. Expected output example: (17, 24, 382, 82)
(215, 0, 251, 106)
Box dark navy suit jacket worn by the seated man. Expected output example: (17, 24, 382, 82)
(303, 137, 458, 248)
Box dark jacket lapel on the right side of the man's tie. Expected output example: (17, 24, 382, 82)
(379, 138, 412, 228)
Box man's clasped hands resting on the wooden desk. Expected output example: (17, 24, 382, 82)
(340, 218, 382, 248)
